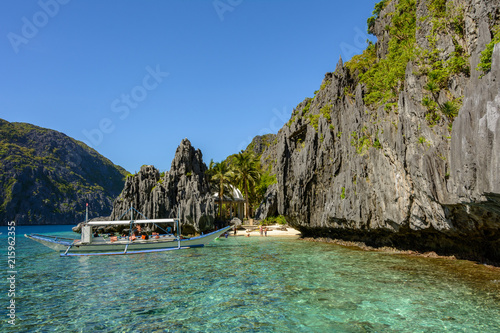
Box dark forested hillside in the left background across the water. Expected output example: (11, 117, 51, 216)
(0, 119, 127, 225)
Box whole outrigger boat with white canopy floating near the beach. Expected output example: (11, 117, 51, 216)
(25, 208, 231, 257)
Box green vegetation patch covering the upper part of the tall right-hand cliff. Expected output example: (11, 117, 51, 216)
(346, 0, 468, 126)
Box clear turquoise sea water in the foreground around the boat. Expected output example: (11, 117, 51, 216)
(0, 226, 500, 332)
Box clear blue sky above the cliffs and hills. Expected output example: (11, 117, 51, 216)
(0, 0, 376, 172)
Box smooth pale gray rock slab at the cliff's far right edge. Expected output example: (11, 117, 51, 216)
(451, 44, 500, 200)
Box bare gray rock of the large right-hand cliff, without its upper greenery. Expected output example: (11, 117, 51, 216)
(258, 0, 500, 262)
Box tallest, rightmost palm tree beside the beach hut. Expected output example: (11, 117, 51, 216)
(233, 152, 260, 218)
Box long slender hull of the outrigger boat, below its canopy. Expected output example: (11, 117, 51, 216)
(25, 226, 231, 256)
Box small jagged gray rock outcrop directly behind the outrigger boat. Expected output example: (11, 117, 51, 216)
(111, 139, 215, 231)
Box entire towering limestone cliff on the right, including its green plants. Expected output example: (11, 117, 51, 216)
(258, 0, 500, 262)
